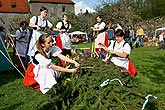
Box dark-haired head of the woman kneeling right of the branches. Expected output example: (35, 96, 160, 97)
(115, 29, 124, 43)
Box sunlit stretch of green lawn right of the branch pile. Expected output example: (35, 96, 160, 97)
(131, 47, 165, 102)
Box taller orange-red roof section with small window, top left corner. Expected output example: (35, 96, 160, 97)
(0, 0, 30, 13)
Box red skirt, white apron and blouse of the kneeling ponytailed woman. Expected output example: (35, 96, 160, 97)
(23, 46, 62, 94)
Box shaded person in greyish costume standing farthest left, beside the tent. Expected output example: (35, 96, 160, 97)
(15, 21, 30, 58)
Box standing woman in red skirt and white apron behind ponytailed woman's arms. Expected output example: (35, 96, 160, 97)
(53, 14, 71, 67)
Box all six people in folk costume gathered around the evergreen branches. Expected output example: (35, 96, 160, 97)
(13, 7, 138, 94)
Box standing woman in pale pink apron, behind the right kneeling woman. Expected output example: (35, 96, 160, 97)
(91, 15, 108, 52)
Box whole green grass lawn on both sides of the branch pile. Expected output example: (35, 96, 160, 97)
(0, 43, 165, 110)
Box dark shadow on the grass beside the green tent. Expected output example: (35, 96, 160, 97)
(0, 70, 22, 87)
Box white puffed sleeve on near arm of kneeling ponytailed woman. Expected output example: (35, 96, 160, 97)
(35, 54, 51, 68)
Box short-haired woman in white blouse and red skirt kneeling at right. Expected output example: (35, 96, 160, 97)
(100, 29, 137, 76)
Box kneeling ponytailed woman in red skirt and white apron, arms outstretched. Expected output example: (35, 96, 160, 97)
(23, 34, 79, 94)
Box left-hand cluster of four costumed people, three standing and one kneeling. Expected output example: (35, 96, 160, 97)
(15, 7, 79, 94)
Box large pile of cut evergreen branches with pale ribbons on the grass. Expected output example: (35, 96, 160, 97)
(37, 57, 163, 110)
